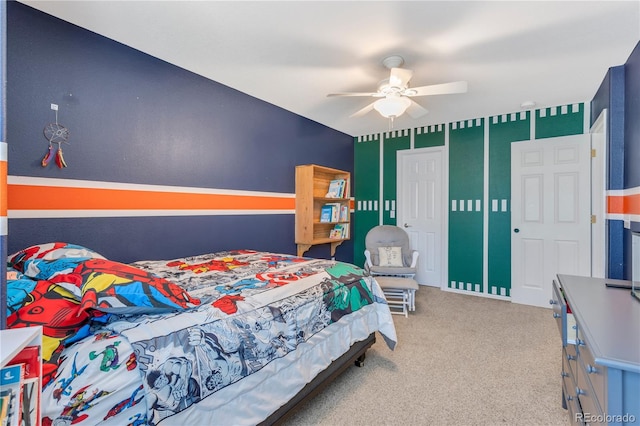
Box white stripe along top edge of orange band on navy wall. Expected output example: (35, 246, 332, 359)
(7, 175, 296, 198)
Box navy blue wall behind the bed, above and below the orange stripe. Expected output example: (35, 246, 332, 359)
(7, 2, 353, 261)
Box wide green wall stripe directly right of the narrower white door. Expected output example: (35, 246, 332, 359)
(448, 119, 485, 292)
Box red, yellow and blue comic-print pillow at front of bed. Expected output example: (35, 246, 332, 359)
(74, 259, 200, 314)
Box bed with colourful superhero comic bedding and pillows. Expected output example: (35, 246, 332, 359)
(7, 243, 396, 425)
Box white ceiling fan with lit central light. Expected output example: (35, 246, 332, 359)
(327, 56, 467, 124)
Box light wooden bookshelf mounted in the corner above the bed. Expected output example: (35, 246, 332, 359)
(296, 164, 351, 256)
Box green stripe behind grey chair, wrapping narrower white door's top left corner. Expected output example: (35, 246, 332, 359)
(381, 131, 411, 225)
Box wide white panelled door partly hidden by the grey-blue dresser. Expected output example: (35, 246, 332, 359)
(511, 135, 591, 307)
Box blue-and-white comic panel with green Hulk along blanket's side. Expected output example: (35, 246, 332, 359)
(133, 265, 372, 424)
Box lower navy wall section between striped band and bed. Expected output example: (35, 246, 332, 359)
(9, 215, 298, 262)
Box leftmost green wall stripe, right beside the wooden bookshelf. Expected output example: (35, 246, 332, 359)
(351, 135, 380, 266)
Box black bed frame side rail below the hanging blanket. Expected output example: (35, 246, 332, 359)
(260, 333, 376, 426)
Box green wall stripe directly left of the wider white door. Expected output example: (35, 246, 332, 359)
(487, 111, 531, 296)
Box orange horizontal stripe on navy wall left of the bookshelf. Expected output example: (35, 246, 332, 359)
(7, 185, 295, 210)
